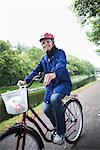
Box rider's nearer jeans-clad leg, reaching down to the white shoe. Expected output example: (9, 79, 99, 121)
(50, 93, 66, 135)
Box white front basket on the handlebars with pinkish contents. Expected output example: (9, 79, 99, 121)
(1, 87, 28, 115)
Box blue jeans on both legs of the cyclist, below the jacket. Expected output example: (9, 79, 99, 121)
(44, 93, 66, 135)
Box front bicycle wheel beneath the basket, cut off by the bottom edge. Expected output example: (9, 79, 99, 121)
(0, 128, 42, 150)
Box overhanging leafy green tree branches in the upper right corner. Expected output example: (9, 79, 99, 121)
(74, 0, 100, 45)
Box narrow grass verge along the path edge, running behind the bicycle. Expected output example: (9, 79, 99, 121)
(0, 80, 100, 132)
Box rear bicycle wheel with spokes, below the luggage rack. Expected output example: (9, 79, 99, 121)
(65, 99, 83, 144)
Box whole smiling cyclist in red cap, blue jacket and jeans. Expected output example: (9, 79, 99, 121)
(21, 33, 72, 144)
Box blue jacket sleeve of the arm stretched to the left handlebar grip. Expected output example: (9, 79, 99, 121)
(24, 60, 43, 83)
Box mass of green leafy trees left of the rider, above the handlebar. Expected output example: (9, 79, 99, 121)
(0, 40, 43, 85)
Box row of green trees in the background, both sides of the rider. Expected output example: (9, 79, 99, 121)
(0, 40, 94, 86)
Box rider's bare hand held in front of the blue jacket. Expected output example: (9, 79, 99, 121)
(44, 73, 56, 86)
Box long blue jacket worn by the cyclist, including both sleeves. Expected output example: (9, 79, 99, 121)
(25, 47, 72, 103)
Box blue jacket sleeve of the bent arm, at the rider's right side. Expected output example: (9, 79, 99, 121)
(51, 50, 67, 80)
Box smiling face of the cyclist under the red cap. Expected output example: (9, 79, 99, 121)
(41, 39, 54, 52)
